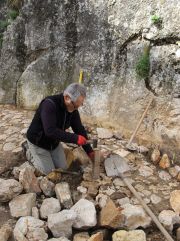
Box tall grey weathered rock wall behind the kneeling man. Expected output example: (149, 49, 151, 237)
(0, 0, 180, 148)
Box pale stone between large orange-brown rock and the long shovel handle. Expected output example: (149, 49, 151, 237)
(122, 203, 151, 229)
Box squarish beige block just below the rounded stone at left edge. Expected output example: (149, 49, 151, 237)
(9, 193, 36, 217)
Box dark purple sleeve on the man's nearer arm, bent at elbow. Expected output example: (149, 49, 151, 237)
(41, 99, 78, 144)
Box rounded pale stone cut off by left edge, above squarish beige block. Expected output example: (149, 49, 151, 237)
(0, 179, 23, 202)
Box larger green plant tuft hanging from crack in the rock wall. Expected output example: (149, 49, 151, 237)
(136, 46, 150, 79)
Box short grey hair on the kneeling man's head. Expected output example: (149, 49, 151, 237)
(63, 83, 86, 101)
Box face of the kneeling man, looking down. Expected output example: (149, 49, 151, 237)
(64, 95, 85, 112)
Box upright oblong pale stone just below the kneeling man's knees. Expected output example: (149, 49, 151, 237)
(55, 182, 73, 209)
